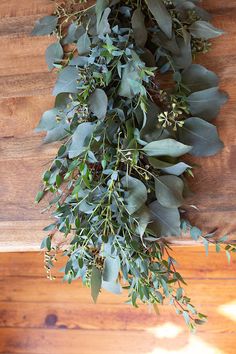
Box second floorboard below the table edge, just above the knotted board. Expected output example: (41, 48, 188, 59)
(0, 275, 235, 311)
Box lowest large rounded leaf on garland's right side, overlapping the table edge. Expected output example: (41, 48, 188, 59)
(149, 201, 181, 237)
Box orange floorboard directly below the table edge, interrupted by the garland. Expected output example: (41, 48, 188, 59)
(0, 246, 236, 279)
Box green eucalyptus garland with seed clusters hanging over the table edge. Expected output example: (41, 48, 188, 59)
(32, 0, 235, 329)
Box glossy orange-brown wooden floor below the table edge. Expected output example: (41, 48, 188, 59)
(0, 247, 236, 354)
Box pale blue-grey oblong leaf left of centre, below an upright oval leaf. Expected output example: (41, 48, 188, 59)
(69, 122, 96, 159)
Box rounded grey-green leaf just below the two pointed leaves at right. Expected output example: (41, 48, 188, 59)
(155, 175, 184, 208)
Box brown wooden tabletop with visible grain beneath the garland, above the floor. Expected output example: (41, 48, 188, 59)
(0, 0, 236, 251)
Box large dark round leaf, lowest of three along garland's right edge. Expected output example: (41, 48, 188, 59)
(179, 117, 224, 156)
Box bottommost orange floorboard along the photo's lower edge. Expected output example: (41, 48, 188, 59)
(0, 327, 235, 354)
